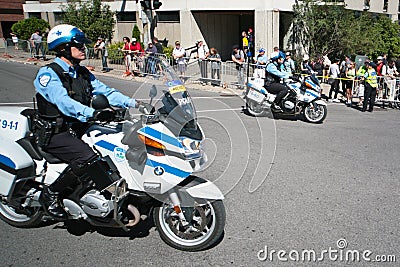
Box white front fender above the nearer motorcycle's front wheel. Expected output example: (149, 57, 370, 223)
(184, 177, 224, 200)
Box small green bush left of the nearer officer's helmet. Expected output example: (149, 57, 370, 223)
(11, 17, 50, 40)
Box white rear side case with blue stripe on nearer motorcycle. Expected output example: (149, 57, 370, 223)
(0, 137, 34, 196)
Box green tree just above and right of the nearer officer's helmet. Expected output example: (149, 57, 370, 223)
(62, 0, 115, 44)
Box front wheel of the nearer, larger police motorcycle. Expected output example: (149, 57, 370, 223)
(154, 200, 226, 251)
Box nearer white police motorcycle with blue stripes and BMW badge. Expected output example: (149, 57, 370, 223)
(0, 59, 225, 251)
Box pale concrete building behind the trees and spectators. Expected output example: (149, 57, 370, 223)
(18, 0, 400, 59)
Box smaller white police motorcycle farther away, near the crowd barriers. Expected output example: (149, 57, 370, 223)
(245, 74, 327, 123)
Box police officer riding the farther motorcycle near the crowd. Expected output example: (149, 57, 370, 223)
(264, 52, 289, 112)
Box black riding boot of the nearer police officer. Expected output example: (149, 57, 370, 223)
(39, 166, 78, 219)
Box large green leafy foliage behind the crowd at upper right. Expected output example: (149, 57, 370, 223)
(292, 0, 400, 57)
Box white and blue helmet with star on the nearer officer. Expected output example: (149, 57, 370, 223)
(47, 24, 91, 52)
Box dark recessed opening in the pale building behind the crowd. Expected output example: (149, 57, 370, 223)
(192, 11, 254, 60)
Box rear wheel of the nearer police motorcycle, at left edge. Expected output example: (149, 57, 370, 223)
(0, 202, 43, 228)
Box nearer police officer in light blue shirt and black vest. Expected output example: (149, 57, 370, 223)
(34, 24, 143, 219)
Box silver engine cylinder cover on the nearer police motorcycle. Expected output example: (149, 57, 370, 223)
(80, 190, 114, 218)
